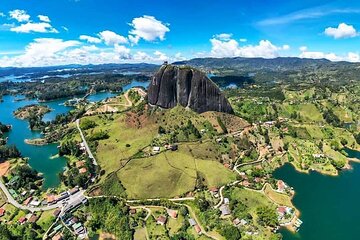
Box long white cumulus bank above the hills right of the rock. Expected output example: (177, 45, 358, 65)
(210, 37, 290, 58)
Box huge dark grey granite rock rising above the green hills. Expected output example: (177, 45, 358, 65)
(148, 65, 233, 113)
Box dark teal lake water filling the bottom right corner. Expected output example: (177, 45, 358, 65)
(274, 150, 360, 240)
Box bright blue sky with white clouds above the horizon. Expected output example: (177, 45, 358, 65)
(0, 0, 360, 67)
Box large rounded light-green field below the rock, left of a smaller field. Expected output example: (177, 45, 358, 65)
(118, 150, 196, 198)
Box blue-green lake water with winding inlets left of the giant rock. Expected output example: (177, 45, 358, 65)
(0, 81, 149, 188)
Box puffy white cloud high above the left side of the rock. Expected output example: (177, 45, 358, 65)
(129, 15, 170, 44)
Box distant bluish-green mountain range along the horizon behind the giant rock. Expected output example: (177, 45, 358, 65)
(0, 57, 360, 77)
